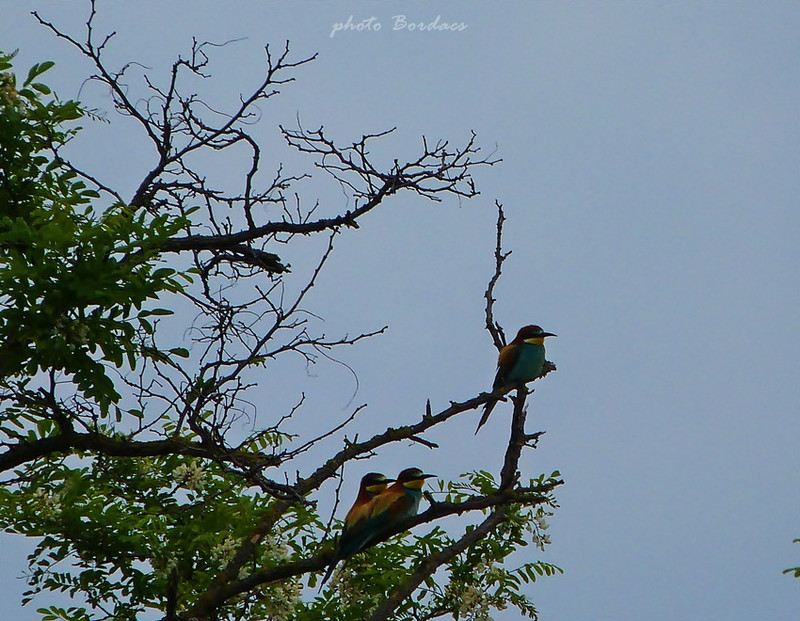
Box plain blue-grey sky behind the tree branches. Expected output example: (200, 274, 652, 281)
(0, 0, 800, 621)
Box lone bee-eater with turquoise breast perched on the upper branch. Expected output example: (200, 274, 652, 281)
(475, 326, 555, 434)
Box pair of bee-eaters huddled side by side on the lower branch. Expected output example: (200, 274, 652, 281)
(320, 468, 436, 588)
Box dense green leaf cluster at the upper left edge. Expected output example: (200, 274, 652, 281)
(0, 55, 184, 413)
